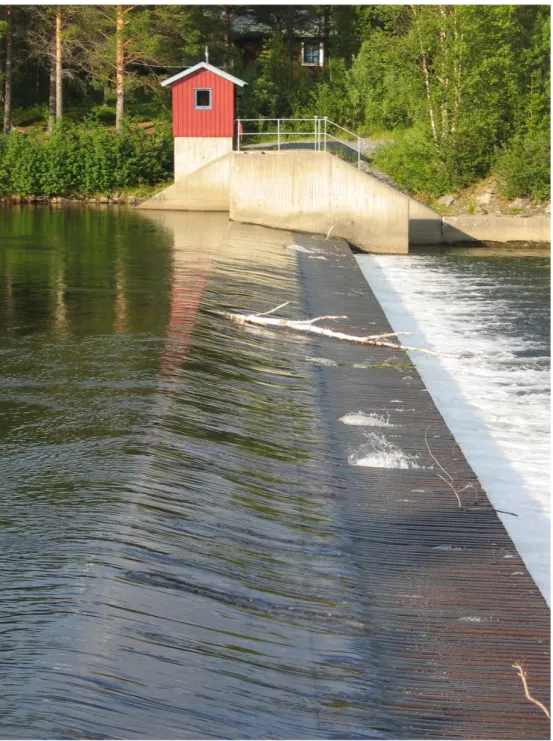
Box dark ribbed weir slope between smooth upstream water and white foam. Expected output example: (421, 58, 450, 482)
(295, 236, 550, 738)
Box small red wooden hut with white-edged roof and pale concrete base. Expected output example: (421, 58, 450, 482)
(161, 62, 247, 180)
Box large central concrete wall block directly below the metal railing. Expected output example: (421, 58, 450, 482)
(230, 150, 409, 254)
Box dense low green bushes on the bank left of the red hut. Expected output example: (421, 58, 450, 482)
(0, 120, 172, 196)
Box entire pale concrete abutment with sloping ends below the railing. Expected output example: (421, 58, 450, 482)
(140, 150, 442, 254)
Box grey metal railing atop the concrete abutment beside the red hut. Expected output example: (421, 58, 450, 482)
(236, 116, 362, 167)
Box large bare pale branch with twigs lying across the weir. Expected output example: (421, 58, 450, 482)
(215, 310, 438, 356)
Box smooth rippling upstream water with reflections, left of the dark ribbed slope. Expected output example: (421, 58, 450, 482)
(0, 209, 378, 738)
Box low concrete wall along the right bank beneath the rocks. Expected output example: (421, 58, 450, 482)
(442, 215, 551, 244)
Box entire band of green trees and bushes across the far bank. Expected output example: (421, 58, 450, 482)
(0, 4, 551, 199)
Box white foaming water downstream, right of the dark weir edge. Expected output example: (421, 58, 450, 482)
(357, 254, 550, 604)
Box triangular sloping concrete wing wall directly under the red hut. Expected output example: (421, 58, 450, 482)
(138, 154, 233, 212)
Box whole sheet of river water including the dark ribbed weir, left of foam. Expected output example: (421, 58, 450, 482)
(0, 209, 549, 739)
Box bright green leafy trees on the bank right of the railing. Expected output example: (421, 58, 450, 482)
(350, 5, 550, 198)
